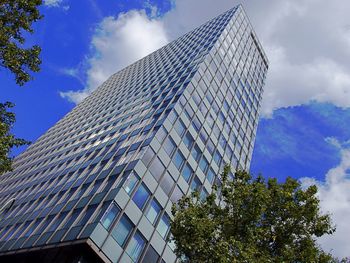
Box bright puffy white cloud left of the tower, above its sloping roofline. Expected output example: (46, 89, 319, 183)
(60, 10, 168, 103)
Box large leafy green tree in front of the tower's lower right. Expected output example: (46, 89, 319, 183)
(171, 166, 336, 263)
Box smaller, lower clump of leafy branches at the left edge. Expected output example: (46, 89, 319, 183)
(0, 102, 29, 174)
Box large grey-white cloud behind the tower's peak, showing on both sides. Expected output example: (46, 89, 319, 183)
(163, 0, 350, 117)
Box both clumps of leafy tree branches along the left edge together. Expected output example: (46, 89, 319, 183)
(0, 0, 42, 174)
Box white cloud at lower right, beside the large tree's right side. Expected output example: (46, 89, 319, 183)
(301, 138, 350, 258)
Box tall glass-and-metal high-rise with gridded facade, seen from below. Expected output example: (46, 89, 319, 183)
(0, 6, 268, 263)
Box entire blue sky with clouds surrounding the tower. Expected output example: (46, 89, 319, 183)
(0, 0, 350, 257)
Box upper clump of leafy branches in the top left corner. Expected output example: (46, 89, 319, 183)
(0, 0, 42, 86)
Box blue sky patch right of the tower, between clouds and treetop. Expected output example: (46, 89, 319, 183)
(250, 102, 344, 181)
